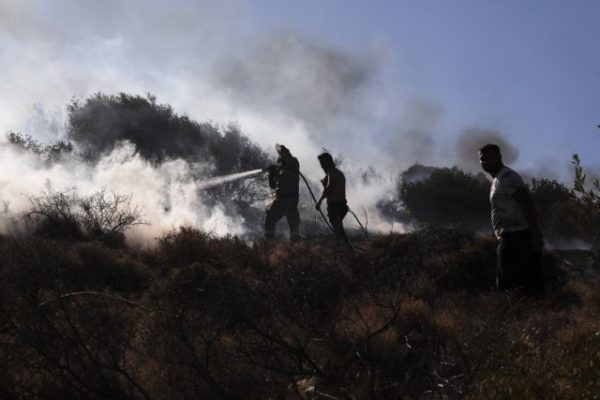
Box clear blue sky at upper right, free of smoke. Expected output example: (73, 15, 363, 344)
(250, 0, 600, 173)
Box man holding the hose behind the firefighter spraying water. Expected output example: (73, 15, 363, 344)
(316, 153, 348, 244)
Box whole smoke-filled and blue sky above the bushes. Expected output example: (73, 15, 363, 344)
(0, 0, 600, 178)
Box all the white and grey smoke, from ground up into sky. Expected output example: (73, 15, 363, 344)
(0, 0, 572, 241)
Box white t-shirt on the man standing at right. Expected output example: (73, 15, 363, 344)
(490, 166, 529, 238)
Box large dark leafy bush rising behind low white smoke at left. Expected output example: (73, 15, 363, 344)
(67, 93, 268, 175)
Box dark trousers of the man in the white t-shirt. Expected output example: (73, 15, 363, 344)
(496, 229, 544, 291)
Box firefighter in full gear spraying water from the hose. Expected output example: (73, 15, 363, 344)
(265, 144, 300, 241)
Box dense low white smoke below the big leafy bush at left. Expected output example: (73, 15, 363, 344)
(0, 143, 251, 242)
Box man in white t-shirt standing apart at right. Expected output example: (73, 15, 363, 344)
(479, 144, 544, 292)
